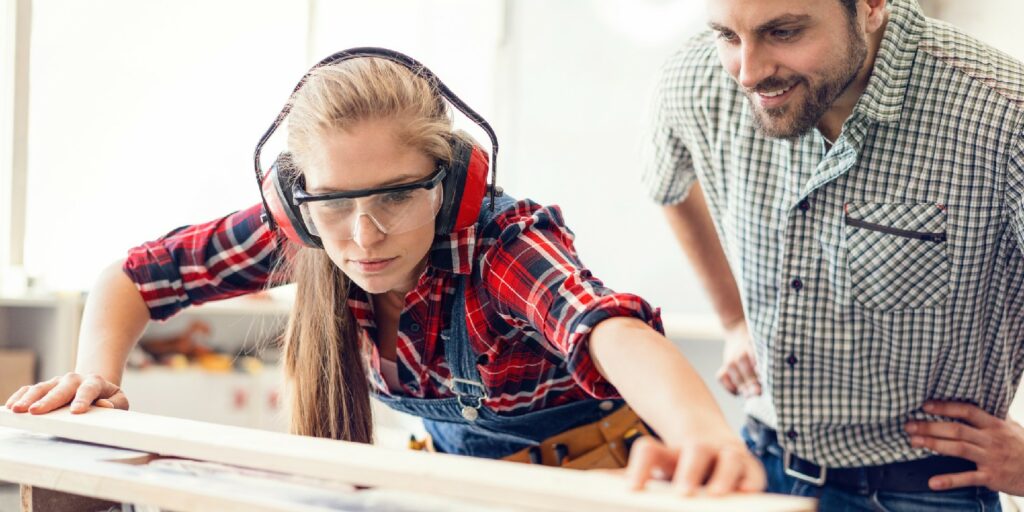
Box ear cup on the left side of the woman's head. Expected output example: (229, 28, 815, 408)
(260, 152, 324, 248)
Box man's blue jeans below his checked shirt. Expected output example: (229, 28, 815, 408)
(741, 427, 1001, 512)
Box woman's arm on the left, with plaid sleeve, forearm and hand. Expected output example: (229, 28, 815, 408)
(6, 205, 287, 414)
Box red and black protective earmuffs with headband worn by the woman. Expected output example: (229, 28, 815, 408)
(253, 47, 501, 248)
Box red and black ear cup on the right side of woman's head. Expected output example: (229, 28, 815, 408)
(435, 137, 487, 234)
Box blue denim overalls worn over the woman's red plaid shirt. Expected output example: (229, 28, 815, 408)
(375, 196, 624, 459)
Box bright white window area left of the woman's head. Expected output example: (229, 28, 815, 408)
(26, 0, 307, 289)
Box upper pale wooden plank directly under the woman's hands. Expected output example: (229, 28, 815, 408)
(0, 408, 815, 512)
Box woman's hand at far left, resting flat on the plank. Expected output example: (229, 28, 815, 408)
(6, 373, 128, 415)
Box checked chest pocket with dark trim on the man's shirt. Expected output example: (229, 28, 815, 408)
(844, 203, 949, 310)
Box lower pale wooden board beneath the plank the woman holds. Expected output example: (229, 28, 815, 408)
(0, 428, 512, 512)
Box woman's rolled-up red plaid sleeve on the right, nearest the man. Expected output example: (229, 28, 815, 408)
(481, 201, 664, 398)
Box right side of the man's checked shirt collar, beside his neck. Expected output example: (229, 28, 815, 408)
(854, 0, 925, 123)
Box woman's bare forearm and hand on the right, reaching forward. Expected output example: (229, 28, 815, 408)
(589, 316, 766, 495)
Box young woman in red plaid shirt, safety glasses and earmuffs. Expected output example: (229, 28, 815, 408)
(6, 49, 765, 493)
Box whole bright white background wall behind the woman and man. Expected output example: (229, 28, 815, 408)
(14, 0, 1024, 313)
